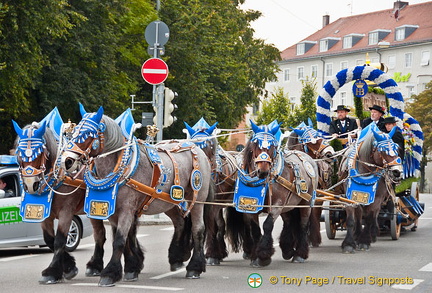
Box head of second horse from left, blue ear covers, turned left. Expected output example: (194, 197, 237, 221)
(61, 103, 105, 173)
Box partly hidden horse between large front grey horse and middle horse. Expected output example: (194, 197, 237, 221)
(185, 118, 237, 265)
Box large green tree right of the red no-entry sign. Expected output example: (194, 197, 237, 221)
(160, 0, 280, 137)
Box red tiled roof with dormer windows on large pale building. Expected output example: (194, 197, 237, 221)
(281, 1, 432, 62)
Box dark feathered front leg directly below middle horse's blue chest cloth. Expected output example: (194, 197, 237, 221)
(252, 213, 275, 267)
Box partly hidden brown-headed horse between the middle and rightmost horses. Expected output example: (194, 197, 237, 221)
(285, 120, 335, 247)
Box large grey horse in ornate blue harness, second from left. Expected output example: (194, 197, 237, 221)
(62, 104, 211, 286)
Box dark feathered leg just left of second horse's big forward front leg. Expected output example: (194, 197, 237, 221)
(85, 218, 106, 277)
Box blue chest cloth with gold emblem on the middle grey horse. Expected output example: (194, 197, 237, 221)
(233, 178, 268, 214)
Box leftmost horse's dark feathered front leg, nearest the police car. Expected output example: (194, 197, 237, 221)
(39, 212, 78, 284)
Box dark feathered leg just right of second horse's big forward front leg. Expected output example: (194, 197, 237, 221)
(123, 216, 144, 282)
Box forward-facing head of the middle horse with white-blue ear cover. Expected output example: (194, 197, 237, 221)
(243, 120, 280, 178)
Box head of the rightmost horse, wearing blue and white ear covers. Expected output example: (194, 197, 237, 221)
(371, 124, 403, 182)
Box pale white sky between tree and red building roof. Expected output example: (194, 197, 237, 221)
(242, 0, 429, 51)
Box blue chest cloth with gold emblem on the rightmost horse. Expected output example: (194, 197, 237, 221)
(346, 169, 381, 205)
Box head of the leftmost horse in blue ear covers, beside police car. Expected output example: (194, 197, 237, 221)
(12, 120, 48, 194)
